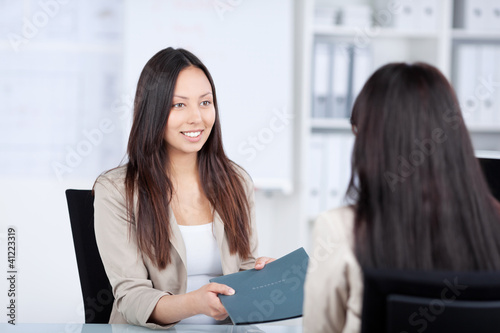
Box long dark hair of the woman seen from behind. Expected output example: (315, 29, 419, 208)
(347, 63, 500, 270)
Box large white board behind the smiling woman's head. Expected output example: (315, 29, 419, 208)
(123, 0, 294, 192)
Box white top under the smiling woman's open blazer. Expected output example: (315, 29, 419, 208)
(179, 222, 222, 325)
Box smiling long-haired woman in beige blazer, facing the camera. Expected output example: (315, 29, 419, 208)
(94, 48, 273, 328)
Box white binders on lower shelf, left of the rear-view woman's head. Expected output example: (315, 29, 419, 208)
(308, 133, 354, 218)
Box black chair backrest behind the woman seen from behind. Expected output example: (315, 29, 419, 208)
(361, 269, 500, 333)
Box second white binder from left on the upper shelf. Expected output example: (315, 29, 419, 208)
(330, 43, 352, 118)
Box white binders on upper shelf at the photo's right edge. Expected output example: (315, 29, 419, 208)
(454, 43, 500, 126)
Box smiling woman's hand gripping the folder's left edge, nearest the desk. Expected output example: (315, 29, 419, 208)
(193, 282, 234, 320)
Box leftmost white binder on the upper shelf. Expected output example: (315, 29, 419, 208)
(312, 42, 331, 118)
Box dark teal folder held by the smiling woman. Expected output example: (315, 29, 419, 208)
(210, 248, 309, 325)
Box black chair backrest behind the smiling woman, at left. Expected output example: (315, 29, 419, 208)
(66, 190, 114, 323)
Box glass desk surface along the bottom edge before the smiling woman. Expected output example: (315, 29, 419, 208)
(0, 323, 302, 333)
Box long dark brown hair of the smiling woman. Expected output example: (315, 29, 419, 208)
(125, 47, 250, 268)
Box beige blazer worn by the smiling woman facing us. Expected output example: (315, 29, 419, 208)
(94, 166, 257, 328)
